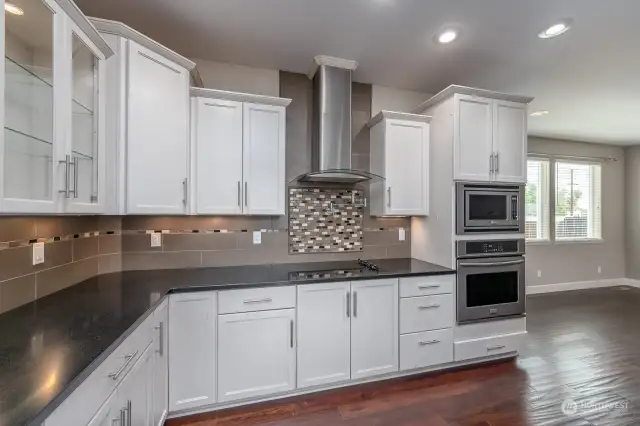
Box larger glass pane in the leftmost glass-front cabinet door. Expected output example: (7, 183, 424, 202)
(4, 0, 53, 200)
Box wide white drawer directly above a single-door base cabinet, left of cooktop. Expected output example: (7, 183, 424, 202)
(218, 286, 296, 314)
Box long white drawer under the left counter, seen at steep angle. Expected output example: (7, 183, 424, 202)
(45, 315, 153, 426)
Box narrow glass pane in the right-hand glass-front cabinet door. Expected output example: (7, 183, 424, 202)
(71, 34, 98, 203)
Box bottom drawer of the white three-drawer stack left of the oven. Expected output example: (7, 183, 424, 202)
(400, 328, 453, 370)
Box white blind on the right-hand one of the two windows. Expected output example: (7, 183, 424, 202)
(555, 161, 602, 240)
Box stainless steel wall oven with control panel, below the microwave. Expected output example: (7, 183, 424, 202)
(457, 239, 526, 323)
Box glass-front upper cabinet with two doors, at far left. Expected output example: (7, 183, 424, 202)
(0, 0, 113, 214)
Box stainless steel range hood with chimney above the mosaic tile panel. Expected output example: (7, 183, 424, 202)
(295, 56, 382, 184)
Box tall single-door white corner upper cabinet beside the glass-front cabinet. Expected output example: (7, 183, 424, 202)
(91, 18, 197, 215)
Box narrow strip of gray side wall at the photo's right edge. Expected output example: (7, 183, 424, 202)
(624, 146, 640, 280)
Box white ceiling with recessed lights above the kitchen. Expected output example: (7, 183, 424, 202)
(76, 0, 640, 145)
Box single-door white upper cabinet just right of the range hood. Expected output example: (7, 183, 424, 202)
(369, 111, 431, 216)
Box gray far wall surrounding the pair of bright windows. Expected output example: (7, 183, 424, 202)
(526, 137, 624, 286)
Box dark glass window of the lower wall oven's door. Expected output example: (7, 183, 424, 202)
(467, 271, 518, 308)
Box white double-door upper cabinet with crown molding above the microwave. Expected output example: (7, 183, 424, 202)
(414, 86, 533, 183)
